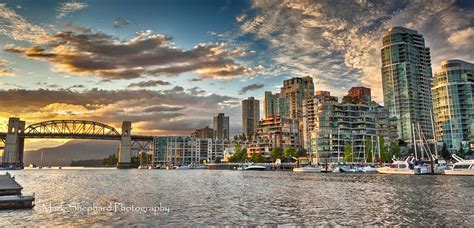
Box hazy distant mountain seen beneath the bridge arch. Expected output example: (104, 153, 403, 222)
(23, 140, 120, 166)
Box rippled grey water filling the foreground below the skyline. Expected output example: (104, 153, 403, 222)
(0, 169, 474, 226)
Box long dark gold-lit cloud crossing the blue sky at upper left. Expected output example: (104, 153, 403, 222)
(5, 26, 258, 79)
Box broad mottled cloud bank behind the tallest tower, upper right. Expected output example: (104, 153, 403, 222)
(236, 0, 474, 101)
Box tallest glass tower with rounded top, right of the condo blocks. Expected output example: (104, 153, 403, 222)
(381, 27, 433, 143)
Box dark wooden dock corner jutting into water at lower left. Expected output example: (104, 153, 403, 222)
(0, 173, 35, 210)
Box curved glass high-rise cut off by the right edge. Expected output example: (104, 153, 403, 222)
(432, 60, 474, 151)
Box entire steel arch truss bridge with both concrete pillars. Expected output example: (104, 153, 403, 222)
(0, 118, 154, 168)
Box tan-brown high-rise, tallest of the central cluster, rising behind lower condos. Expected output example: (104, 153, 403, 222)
(279, 76, 314, 120)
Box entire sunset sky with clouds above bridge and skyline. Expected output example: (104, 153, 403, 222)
(0, 0, 474, 150)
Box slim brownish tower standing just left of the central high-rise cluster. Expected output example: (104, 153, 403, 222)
(242, 97, 260, 136)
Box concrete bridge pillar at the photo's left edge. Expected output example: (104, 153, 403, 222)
(2, 118, 25, 169)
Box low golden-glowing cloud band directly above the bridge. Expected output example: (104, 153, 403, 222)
(0, 86, 241, 135)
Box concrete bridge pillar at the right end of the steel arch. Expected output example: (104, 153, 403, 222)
(117, 121, 132, 169)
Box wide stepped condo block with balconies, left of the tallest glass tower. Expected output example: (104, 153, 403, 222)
(303, 91, 390, 163)
